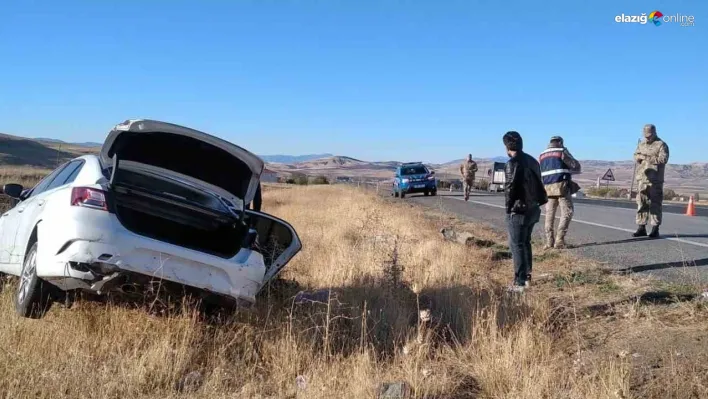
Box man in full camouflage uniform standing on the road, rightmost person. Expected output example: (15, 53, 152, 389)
(633, 124, 669, 238)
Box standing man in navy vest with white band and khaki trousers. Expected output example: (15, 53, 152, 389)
(539, 136, 580, 249)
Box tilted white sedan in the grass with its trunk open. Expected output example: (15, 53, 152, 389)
(0, 120, 301, 318)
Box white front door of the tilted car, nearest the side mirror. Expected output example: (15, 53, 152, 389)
(0, 164, 66, 274)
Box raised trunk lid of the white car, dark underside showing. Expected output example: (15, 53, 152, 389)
(100, 119, 264, 204)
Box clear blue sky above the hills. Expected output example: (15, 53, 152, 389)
(0, 0, 708, 163)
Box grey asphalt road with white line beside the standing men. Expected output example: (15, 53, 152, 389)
(392, 191, 708, 284)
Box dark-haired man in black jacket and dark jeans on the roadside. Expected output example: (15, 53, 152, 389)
(503, 131, 548, 292)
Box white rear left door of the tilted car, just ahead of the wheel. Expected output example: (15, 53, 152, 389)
(10, 160, 84, 269)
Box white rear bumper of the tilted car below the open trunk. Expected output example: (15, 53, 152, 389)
(37, 210, 266, 302)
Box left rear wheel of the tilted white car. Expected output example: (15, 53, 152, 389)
(15, 243, 51, 319)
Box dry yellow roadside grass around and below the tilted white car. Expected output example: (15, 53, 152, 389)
(0, 186, 708, 398)
